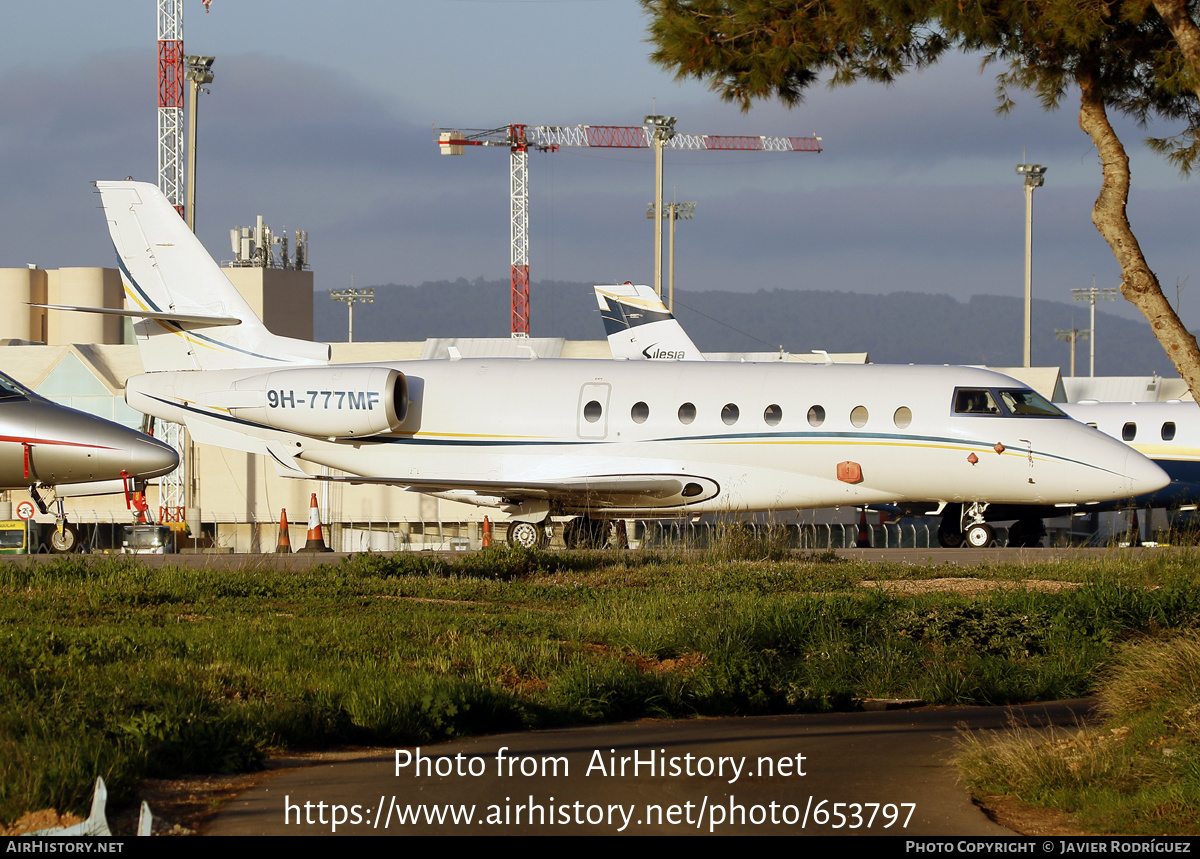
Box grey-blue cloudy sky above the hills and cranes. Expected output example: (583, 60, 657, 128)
(0, 0, 1200, 337)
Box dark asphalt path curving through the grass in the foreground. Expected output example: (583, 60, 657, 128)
(206, 702, 1088, 836)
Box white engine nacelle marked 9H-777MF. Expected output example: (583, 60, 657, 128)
(204, 366, 408, 438)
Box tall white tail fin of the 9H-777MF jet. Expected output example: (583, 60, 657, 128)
(96, 181, 330, 371)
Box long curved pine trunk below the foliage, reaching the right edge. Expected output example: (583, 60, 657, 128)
(1078, 68, 1200, 402)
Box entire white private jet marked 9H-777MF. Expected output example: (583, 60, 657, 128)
(51, 181, 1166, 545)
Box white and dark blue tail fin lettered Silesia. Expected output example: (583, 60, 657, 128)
(595, 283, 704, 361)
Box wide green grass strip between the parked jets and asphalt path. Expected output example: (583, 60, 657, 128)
(0, 547, 1200, 821)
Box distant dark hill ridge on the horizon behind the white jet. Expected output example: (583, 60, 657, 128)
(314, 280, 1176, 376)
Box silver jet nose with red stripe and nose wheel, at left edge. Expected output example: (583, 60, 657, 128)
(0, 373, 179, 552)
